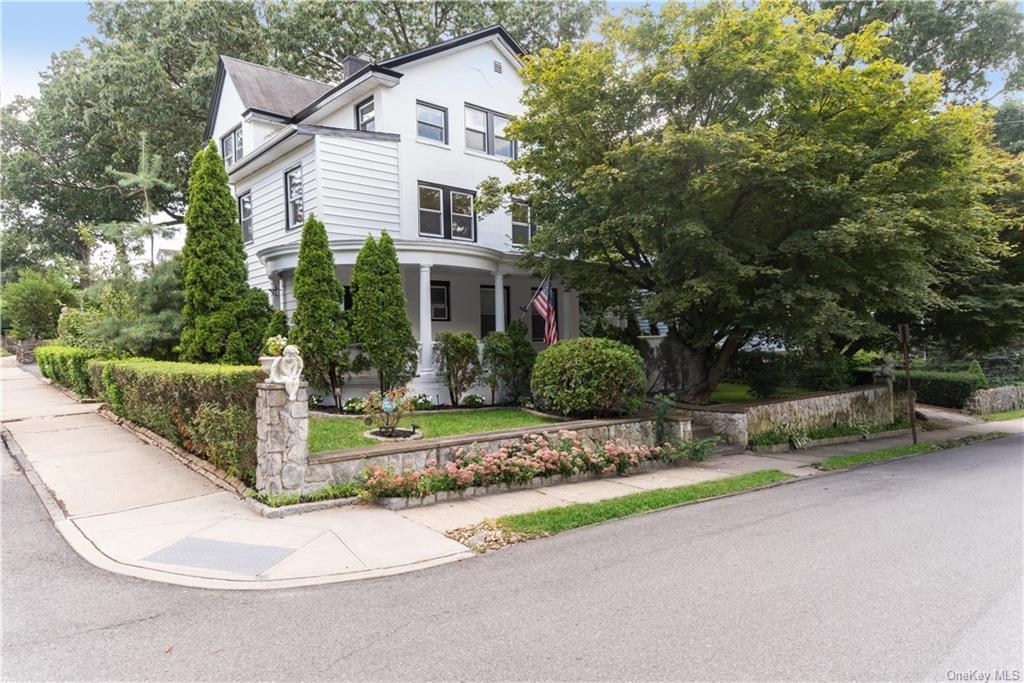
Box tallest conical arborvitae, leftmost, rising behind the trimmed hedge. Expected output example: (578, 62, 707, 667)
(181, 140, 270, 362)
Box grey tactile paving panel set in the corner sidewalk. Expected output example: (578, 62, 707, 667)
(143, 537, 295, 577)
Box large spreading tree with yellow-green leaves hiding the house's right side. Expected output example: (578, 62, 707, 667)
(495, 1, 1002, 402)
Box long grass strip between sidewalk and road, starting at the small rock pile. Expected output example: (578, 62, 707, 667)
(498, 470, 794, 536)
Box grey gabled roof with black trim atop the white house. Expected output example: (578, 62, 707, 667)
(205, 26, 525, 139)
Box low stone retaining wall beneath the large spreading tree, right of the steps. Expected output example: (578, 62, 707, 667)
(674, 384, 895, 447)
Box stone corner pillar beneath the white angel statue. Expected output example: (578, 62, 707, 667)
(256, 382, 309, 496)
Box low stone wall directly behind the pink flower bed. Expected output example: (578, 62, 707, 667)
(303, 418, 675, 492)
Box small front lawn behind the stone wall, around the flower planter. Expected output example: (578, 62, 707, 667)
(309, 408, 557, 453)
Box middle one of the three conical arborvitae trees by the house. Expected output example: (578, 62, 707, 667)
(286, 215, 349, 407)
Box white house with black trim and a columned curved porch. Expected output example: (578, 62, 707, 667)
(206, 27, 579, 399)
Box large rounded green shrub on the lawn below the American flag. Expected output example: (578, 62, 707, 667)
(529, 337, 647, 417)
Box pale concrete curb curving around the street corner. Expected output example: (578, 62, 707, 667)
(0, 427, 474, 591)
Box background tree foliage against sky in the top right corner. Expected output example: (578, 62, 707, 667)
(805, 0, 1024, 102)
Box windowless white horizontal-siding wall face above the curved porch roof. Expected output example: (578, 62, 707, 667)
(316, 135, 399, 239)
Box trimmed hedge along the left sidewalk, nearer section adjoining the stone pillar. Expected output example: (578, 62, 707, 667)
(88, 358, 263, 484)
